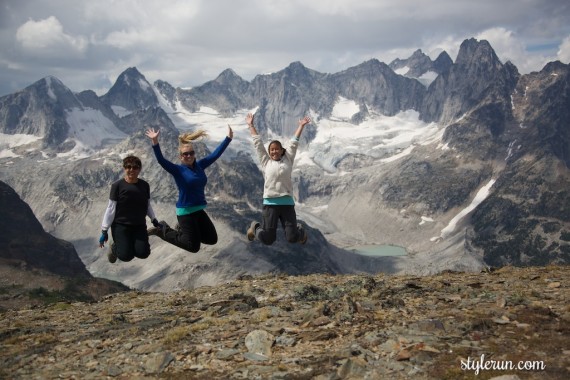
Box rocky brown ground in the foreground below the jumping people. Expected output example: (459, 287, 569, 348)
(0, 266, 570, 380)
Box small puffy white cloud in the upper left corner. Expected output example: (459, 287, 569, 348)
(16, 16, 87, 57)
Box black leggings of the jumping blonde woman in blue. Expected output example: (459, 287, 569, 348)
(164, 210, 218, 252)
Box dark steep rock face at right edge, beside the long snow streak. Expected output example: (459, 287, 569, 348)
(466, 62, 570, 265)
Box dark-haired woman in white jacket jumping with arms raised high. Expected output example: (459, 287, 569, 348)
(245, 113, 311, 245)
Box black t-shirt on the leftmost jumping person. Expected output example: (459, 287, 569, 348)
(109, 178, 150, 226)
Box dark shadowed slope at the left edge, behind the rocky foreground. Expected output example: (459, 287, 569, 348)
(0, 181, 128, 310)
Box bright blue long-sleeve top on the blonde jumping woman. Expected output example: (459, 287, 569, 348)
(152, 136, 232, 208)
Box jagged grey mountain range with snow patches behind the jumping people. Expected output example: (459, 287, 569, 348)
(0, 39, 570, 291)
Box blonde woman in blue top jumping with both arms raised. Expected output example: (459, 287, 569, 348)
(145, 125, 233, 252)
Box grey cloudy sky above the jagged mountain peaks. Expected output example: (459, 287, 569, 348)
(0, 0, 570, 96)
